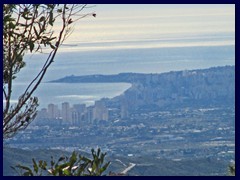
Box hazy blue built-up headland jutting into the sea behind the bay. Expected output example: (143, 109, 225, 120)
(51, 66, 235, 110)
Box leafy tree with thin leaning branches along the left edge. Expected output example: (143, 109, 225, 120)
(3, 4, 96, 139)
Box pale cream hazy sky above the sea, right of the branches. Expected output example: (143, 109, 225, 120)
(62, 4, 235, 46)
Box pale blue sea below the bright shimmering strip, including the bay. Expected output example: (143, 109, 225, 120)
(9, 45, 235, 107)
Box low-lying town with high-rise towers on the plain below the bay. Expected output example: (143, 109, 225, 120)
(7, 101, 235, 160)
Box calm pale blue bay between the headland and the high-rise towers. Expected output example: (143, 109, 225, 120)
(13, 83, 131, 108)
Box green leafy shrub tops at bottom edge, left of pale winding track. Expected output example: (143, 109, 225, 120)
(12, 149, 110, 176)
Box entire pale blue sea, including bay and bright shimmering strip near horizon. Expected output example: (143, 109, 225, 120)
(8, 34, 235, 108)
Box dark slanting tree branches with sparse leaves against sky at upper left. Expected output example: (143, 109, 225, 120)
(3, 4, 94, 138)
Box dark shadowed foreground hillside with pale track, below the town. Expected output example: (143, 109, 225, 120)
(3, 148, 228, 176)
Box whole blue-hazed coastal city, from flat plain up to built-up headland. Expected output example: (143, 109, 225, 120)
(7, 66, 235, 173)
